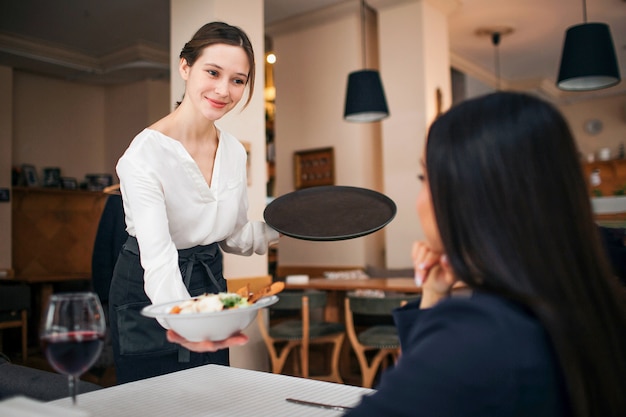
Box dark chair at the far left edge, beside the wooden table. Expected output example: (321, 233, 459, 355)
(0, 284, 30, 363)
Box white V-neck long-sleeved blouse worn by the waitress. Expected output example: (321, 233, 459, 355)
(116, 129, 279, 304)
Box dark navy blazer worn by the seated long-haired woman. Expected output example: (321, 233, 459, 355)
(346, 292, 569, 417)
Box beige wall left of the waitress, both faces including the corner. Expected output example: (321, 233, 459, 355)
(12, 71, 169, 182)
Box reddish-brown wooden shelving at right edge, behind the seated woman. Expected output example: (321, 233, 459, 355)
(583, 159, 626, 197)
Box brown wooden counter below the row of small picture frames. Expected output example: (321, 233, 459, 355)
(12, 187, 108, 279)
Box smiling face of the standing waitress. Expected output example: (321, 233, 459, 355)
(179, 43, 250, 120)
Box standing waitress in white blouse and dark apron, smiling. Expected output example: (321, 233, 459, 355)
(109, 22, 279, 383)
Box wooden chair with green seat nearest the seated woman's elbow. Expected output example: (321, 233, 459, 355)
(344, 294, 419, 388)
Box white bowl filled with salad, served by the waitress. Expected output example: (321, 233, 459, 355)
(141, 292, 278, 342)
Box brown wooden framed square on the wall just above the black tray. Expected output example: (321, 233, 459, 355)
(294, 147, 335, 190)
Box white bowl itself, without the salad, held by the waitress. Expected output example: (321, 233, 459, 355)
(141, 295, 278, 342)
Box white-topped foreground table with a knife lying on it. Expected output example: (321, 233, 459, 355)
(49, 365, 374, 417)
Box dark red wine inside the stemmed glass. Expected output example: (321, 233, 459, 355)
(41, 331, 104, 376)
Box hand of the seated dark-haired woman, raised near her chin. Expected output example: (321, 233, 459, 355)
(411, 242, 457, 308)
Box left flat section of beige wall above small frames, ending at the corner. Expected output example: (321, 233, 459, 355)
(13, 71, 110, 182)
